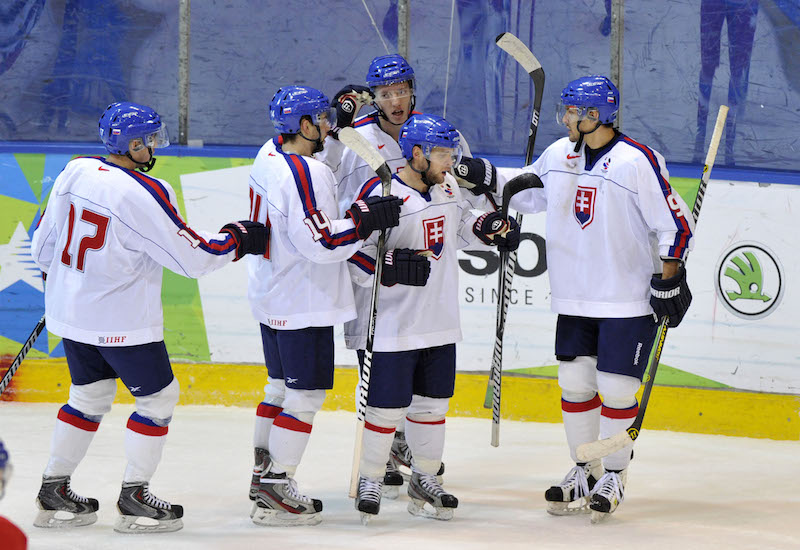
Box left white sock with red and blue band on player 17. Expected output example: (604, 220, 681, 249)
(44, 405, 103, 477)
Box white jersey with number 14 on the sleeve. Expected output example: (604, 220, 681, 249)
(248, 137, 363, 330)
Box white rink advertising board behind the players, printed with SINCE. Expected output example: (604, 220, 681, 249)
(181, 166, 800, 393)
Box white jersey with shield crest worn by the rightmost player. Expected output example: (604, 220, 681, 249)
(498, 134, 694, 318)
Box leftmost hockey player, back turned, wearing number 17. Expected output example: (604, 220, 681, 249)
(31, 102, 268, 533)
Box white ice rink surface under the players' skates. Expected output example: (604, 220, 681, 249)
(0, 402, 800, 550)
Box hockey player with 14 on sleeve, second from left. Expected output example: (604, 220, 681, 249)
(248, 86, 402, 525)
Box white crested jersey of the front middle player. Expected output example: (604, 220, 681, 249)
(344, 175, 477, 351)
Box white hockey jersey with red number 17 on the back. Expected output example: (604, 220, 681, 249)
(31, 157, 236, 346)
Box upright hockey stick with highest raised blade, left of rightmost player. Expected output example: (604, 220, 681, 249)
(489, 32, 544, 447)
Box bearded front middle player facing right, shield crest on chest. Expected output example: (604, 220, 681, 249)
(345, 115, 519, 519)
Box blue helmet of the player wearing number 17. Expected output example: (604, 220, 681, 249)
(98, 101, 169, 155)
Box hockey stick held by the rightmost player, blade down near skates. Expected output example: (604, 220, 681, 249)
(576, 105, 728, 462)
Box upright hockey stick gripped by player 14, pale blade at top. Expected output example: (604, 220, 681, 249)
(339, 128, 392, 498)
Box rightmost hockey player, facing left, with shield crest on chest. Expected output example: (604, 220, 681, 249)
(468, 76, 693, 522)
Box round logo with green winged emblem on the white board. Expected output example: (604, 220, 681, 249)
(714, 242, 786, 319)
